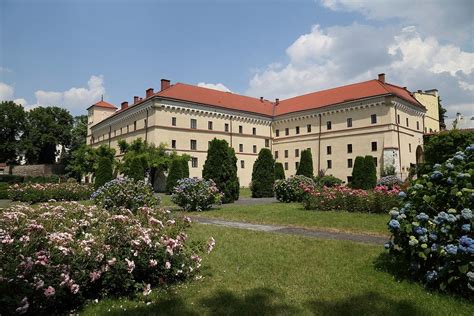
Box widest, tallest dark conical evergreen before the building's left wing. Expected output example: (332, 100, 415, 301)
(202, 138, 239, 203)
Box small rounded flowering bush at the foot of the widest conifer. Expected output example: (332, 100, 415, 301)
(171, 178, 223, 211)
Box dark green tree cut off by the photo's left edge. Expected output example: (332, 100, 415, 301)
(0, 101, 25, 164)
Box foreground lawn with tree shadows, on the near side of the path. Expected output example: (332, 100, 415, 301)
(82, 225, 474, 316)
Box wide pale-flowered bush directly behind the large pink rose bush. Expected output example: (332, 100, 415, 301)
(91, 178, 160, 213)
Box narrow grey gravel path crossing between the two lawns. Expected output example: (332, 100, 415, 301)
(191, 216, 388, 245)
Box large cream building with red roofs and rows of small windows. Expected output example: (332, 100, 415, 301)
(88, 74, 439, 186)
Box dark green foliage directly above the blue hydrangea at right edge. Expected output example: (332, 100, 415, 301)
(423, 129, 474, 164)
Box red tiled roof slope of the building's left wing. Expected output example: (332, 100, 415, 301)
(155, 83, 273, 116)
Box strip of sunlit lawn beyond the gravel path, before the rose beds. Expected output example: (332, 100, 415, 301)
(192, 203, 388, 235)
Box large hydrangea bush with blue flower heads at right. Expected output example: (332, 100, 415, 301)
(385, 145, 474, 297)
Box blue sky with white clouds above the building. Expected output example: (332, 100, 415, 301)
(0, 0, 474, 117)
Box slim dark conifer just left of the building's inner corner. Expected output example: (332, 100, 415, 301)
(250, 148, 275, 198)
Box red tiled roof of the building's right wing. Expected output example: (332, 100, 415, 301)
(275, 80, 423, 115)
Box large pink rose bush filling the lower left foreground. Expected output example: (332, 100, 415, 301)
(0, 202, 211, 315)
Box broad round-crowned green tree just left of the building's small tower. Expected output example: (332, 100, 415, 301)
(22, 106, 73, 164)
